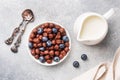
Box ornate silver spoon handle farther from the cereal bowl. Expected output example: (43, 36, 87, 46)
(5, 21, 23, 45)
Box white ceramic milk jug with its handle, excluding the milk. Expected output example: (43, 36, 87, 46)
(74, 8, 115, 45)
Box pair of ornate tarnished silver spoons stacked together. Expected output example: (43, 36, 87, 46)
(5, 9, 34, 53)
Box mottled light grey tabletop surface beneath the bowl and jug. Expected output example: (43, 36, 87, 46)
(0, 0, 120, 80)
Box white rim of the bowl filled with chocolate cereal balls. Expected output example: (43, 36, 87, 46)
(27, 21, 71, 66)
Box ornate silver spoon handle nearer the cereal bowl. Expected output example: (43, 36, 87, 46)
(11, 22, 28, 53)
